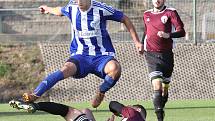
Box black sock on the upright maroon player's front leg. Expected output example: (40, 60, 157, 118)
(153, 90, 164, 121)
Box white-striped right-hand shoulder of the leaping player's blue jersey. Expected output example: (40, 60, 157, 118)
(92, 0, 114, 12)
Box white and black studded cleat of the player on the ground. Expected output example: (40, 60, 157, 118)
(9, 100, 36, 113)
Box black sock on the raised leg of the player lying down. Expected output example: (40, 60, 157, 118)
(32, 102, 69, 117)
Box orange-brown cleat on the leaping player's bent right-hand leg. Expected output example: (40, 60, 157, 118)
(92, 92, 105, 108)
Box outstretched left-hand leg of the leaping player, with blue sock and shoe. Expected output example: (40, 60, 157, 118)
(23, 58, 78, 102)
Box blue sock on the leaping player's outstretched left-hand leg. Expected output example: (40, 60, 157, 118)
(34, 70, 64, 96)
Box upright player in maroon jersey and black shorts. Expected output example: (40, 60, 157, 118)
(143, 0, 185, 121)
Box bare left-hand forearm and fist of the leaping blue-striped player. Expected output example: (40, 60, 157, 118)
(39, 5, 63, 16)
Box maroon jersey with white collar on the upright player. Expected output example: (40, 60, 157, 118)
(143, 7, 184, 52)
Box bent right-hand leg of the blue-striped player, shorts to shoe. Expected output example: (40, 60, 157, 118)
(92, 56, 121, 108)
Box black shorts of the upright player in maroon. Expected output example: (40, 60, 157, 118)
(145, 52, 174, 80)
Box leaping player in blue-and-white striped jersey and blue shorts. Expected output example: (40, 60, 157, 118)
(23, 0, 143, 108)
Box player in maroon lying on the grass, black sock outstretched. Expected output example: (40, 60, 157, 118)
(9, 100, 146, 121)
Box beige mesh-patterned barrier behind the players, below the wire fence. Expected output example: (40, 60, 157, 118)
(40, 42, 215, 102)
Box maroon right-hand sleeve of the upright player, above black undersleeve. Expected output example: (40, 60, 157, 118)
(171, 10, 184, 31)
